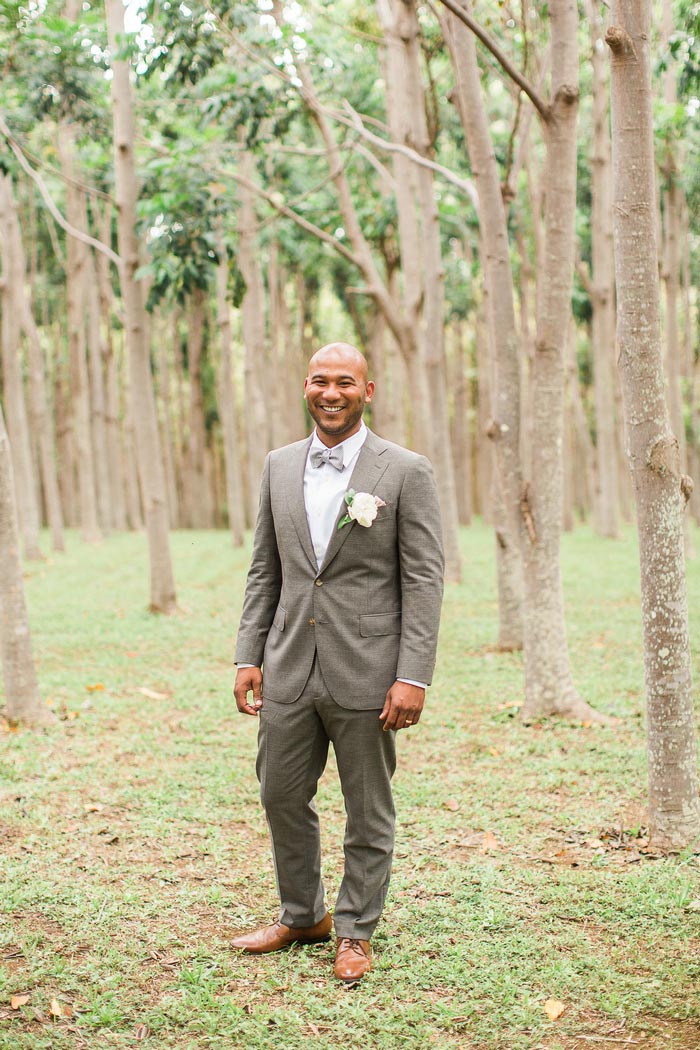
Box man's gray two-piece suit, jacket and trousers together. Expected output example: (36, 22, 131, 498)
(236, 432, 444, 939)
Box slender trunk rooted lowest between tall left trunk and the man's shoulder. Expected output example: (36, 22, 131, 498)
(216, 227, 246, 547)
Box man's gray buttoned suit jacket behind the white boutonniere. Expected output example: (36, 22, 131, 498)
(236, 431, 444, 710)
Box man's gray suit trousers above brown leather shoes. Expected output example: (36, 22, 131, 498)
(256, 656, 396, 940)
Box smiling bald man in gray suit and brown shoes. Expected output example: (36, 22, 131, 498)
(233, 342, 443, 983)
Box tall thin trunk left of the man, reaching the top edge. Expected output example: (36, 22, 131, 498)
(105, 0, 176, 612)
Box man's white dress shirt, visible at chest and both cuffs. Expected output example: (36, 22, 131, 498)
(238, 423, 427, 689)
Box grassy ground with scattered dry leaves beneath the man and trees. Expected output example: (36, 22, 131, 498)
(0, 526, 700, 1050)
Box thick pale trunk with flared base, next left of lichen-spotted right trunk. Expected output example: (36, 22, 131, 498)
(523, 0, 600, 721)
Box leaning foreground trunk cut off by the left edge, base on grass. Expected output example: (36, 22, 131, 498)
(0, 406, 50, 722)
